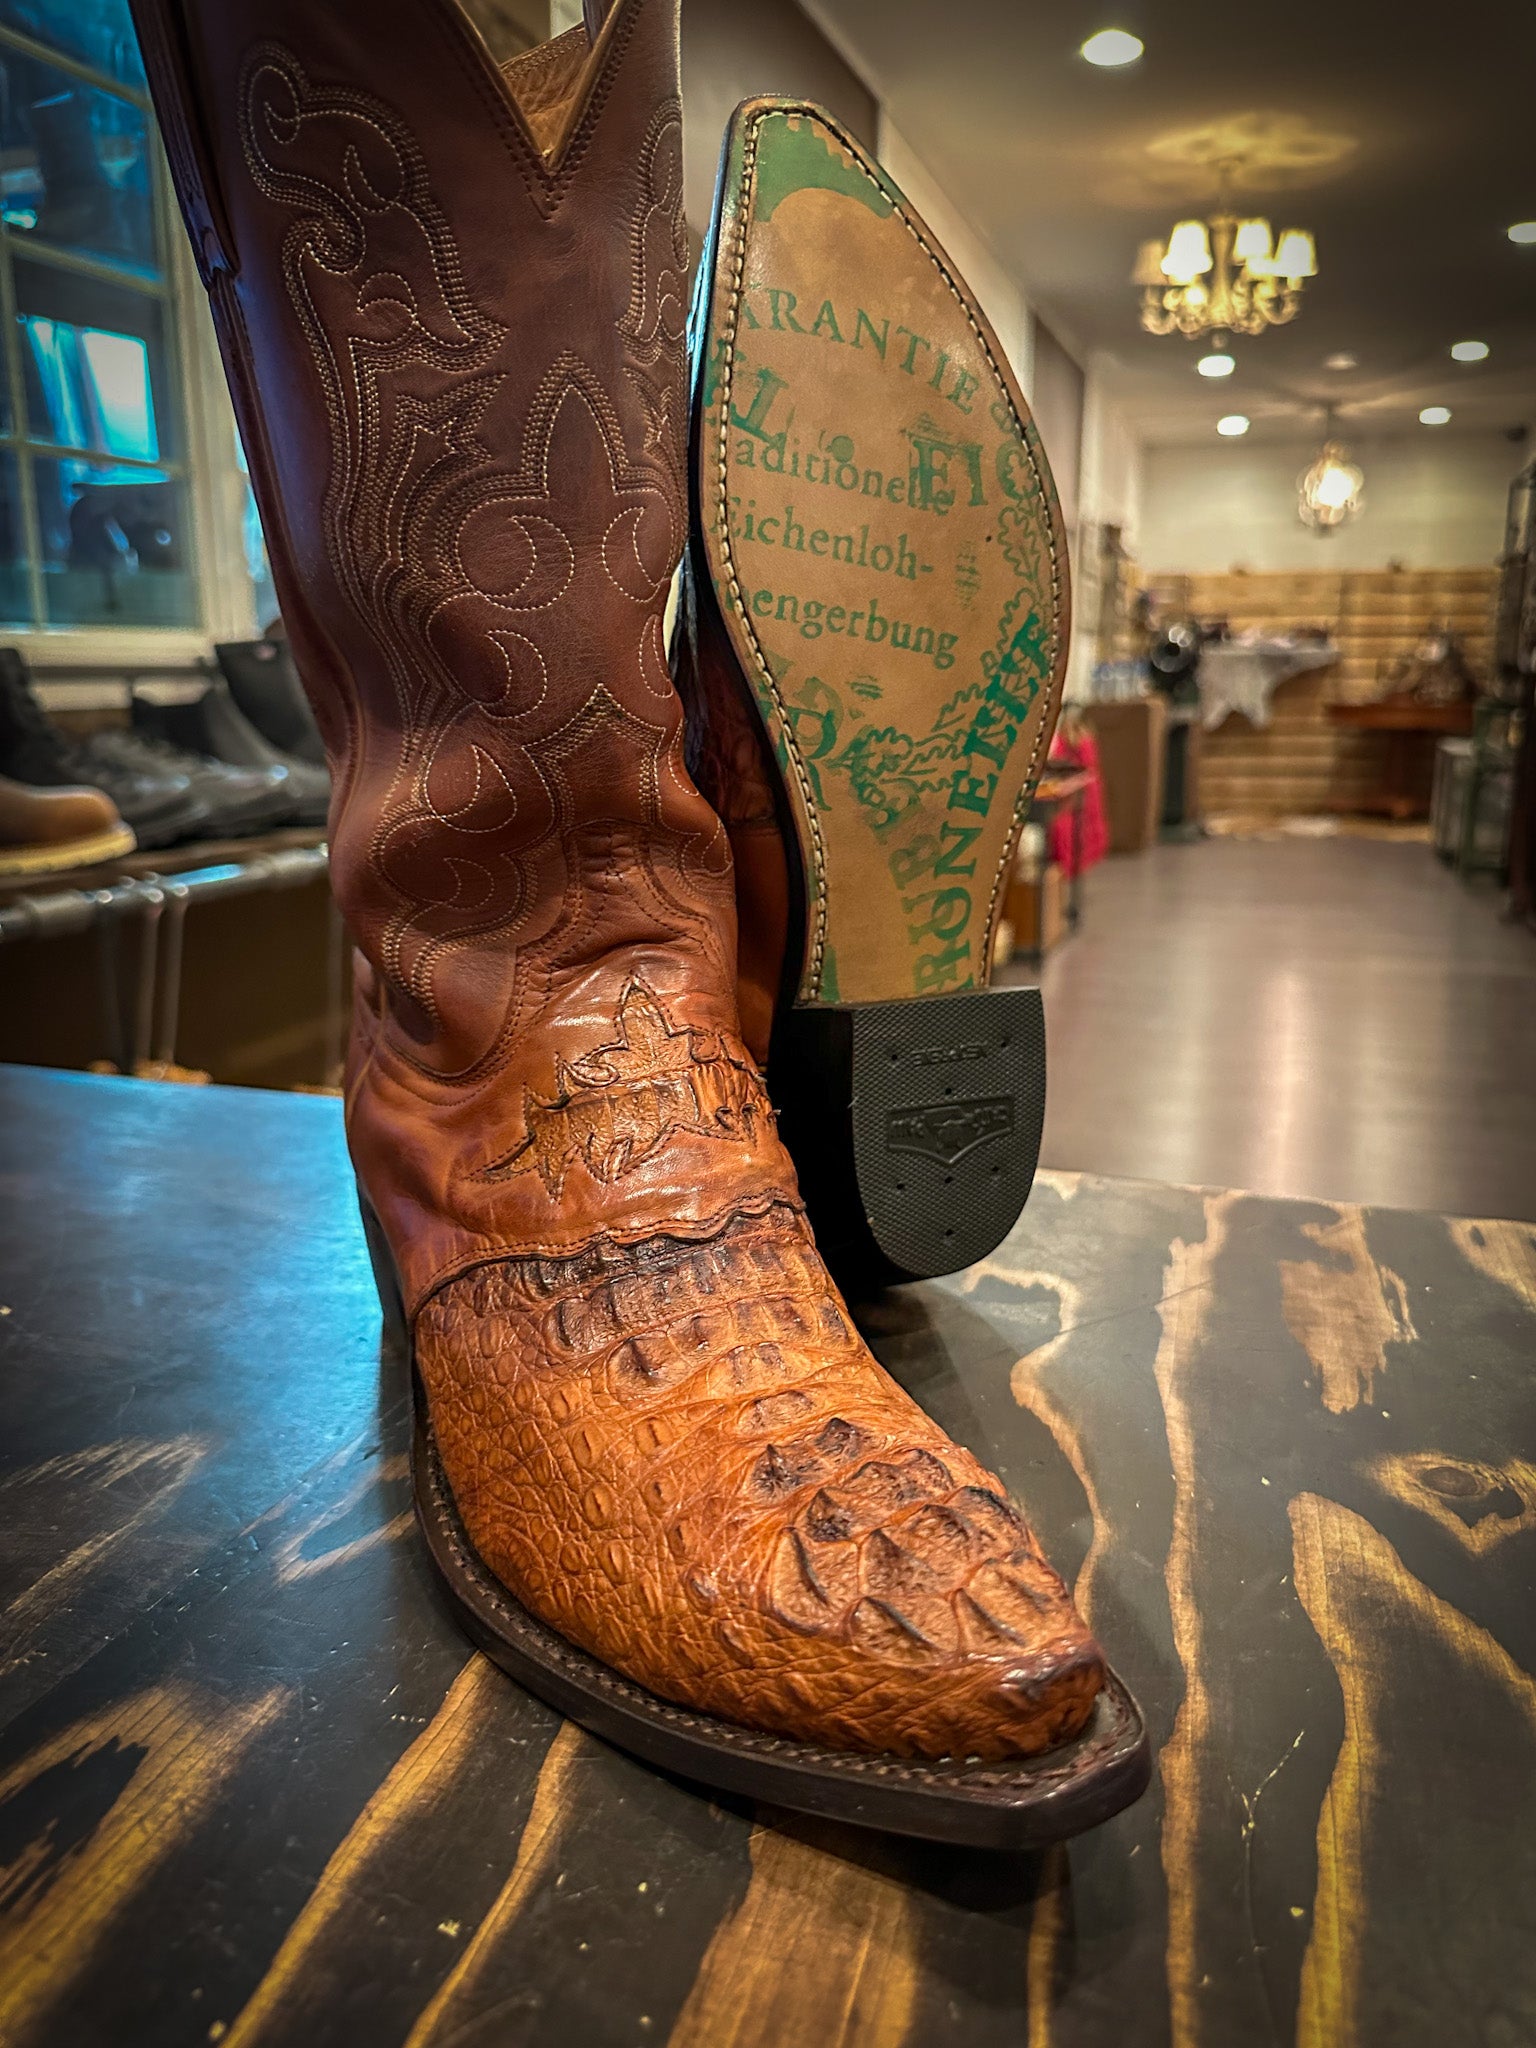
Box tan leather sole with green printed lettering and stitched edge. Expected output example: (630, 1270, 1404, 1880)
(694, 100, 1069, 1004)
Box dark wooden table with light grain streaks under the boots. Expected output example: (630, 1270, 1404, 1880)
(0, 1069, 1536, 2048)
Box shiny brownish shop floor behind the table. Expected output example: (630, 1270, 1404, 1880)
(1024, 838, 1536, 1221)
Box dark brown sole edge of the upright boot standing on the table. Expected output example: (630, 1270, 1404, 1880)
(358, 1196, 1151, 1851)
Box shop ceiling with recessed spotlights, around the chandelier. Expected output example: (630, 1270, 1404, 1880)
(813, 0, 1536, 444)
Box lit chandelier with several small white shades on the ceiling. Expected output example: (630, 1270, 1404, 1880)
(1130, 166, 1317, 340)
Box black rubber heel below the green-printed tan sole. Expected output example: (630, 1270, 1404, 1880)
(768, 989, 1044, 1286)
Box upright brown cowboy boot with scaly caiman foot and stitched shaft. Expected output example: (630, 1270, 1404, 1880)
(135, 0, 1147, 1843)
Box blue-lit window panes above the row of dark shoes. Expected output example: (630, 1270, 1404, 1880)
(0, 0, 199, 629)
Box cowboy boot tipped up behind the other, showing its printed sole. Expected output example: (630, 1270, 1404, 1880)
(676, 100, 1067, 1282)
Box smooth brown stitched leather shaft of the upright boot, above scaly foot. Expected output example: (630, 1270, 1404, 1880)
(139, 0, 793, 1303)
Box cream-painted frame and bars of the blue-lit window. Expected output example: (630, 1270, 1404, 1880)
(0, 23, 256, 671)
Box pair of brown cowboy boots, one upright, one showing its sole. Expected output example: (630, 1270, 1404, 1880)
(135, 0, 1147, 1845)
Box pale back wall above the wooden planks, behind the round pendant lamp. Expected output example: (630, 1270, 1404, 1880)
(1137, 428, 1528, 573)
